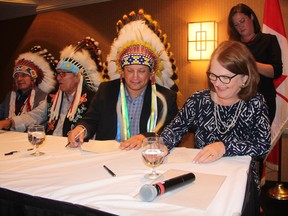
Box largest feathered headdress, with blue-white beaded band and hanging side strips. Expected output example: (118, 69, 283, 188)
(103, 9, 178, 140)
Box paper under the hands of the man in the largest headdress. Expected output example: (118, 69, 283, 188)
(81, 140, 120, 153)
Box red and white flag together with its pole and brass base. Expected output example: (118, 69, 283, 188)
(263, 0, 288, 200)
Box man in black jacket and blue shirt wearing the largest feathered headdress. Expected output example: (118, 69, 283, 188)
(68, 9, 178, 150)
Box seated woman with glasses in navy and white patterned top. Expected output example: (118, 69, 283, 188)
(161, 41, 271, 215)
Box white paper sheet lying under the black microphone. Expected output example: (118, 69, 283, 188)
(153, 169, 226, 210)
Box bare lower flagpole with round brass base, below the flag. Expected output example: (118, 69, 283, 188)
(268, 135, 288, 200)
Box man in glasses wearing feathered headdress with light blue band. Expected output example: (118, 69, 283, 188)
(0, 37, 103, 136)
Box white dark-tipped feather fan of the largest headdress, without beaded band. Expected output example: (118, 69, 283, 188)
(104, 9, 179, 92)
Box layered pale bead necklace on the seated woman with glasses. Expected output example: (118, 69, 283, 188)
(214, 100, 244, 134)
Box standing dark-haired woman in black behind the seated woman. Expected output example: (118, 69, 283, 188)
(228, 4, 282, 124)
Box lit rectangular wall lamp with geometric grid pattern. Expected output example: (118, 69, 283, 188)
(188, 21, 217, 61)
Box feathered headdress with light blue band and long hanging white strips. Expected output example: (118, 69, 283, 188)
(49, 37, 103, 122)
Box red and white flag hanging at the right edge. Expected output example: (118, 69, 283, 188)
(263, 0, 288, 170)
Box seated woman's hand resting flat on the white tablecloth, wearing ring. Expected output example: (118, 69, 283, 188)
(193, 142, 225, 163)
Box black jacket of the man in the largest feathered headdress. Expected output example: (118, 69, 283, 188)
(77, 79, 178, 140)
